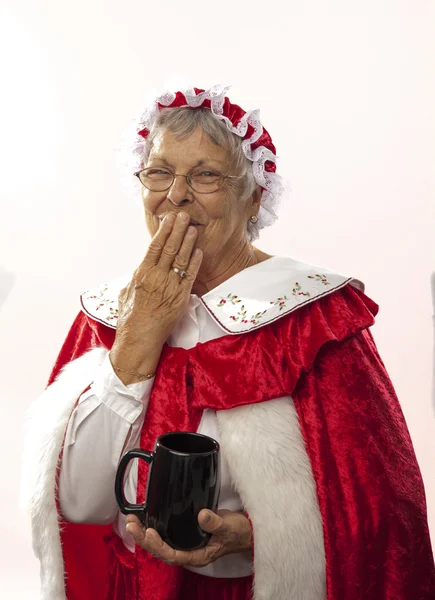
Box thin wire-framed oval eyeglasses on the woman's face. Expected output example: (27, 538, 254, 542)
(134, 167, 238, 194)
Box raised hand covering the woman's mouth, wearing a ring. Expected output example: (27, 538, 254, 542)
(110, 212, 202, 384)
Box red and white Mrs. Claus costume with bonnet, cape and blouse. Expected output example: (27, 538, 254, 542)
(25, 87, 435, 600)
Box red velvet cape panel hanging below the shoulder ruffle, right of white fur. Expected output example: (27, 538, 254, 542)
(293, 330, 435, 600)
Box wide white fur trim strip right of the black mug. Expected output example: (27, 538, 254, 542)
(217, 397, 326, 600)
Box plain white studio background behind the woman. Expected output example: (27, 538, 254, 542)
(0, 0, 435, 599)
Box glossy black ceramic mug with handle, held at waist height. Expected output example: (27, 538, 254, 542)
(115, 432, 220, 550)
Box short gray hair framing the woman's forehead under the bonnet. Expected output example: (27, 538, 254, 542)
(142, 107, 259, 241)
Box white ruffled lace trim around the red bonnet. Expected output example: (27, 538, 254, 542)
(117, 84, 284, 240)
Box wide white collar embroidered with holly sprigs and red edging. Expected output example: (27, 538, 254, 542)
(81, 256, 364, 334)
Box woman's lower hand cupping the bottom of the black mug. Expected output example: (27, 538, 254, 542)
(127, 509, 252, 567)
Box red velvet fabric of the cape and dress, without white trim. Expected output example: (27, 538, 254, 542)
(50, 286, 435, 600)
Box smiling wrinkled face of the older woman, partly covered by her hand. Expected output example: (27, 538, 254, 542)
(142, 127, 258, 264)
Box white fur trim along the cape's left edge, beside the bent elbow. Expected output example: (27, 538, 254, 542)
(21, 348, 107, 600)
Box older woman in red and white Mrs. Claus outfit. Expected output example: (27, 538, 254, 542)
(23, 87, 435, 600)
